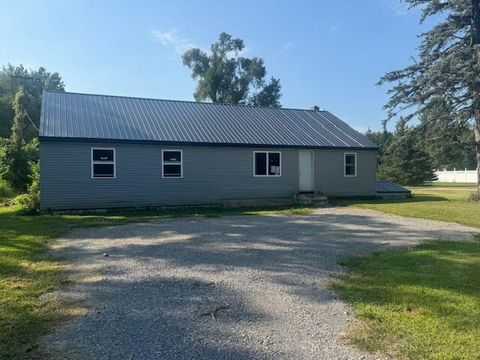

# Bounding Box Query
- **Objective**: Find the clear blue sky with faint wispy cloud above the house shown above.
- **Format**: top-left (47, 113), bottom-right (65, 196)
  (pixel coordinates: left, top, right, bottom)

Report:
top-left (0, 0), bottom-right (428, 131)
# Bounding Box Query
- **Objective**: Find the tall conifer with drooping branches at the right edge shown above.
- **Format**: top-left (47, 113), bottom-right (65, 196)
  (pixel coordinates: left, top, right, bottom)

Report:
top-left (379, 0), bottom-right (480, 194)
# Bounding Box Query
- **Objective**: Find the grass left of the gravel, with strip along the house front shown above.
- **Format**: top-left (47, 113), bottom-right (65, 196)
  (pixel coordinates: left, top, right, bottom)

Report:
top-left (0, 199), bottom-right (312, 359)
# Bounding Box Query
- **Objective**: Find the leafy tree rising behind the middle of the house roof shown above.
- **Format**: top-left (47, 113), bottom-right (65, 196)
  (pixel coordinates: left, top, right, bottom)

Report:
top-left (182, 33), bottom-right (281, 107)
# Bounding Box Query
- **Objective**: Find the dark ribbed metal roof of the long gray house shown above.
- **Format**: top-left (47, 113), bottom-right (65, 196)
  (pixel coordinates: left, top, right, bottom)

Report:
top-left (40, 91), bottom-right (376, 149)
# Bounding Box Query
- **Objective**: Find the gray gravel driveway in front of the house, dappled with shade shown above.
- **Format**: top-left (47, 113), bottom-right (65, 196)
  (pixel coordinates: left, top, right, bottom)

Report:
top-left (44, 208), bottom-right (475, 359)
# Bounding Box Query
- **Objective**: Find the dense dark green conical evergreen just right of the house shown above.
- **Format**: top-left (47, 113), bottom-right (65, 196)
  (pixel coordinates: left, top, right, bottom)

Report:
top-left (378, 121), bottom-right (436, 185)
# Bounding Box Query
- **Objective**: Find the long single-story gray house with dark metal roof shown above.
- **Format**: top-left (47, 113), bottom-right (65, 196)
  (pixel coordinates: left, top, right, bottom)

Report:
top-left (40, 92), bottom-right (377, 210)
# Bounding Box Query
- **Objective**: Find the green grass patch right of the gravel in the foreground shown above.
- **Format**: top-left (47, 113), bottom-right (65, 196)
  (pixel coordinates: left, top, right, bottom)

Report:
top-left (333, 239), bottom-right (480, 359)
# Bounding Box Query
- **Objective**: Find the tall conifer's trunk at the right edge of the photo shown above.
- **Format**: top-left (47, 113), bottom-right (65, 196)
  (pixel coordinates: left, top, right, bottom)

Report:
top-left (471, 0), bottom-right (480, 194)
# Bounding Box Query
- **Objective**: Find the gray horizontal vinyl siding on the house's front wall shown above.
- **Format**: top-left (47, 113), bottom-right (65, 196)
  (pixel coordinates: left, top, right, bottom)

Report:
top-left (40, 140), bottom-right (376, 209)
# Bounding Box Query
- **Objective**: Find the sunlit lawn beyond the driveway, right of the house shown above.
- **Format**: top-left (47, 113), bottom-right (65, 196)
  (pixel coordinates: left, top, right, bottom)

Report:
top-left (335, 186), bottom-right (480, 228)
